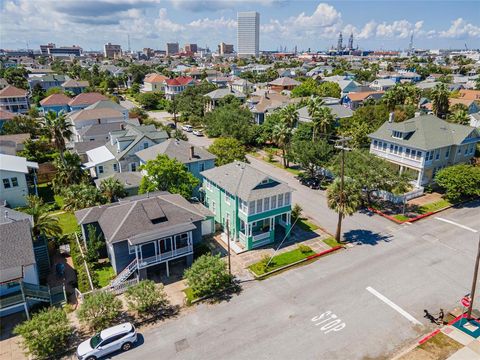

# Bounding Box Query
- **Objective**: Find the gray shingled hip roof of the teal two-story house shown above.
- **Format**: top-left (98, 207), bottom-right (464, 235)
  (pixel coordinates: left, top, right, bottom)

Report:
top-left (201, 161), bottom-right (292, 201)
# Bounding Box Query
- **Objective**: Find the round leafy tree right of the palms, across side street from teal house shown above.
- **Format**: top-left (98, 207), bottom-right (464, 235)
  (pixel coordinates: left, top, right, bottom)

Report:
top-left (292, 140), bottom-right (333, 177)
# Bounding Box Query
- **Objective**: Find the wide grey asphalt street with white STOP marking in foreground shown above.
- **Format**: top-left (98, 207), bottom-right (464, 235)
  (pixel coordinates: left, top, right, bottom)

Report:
top-left (115, 202), bottom-right (480, 359)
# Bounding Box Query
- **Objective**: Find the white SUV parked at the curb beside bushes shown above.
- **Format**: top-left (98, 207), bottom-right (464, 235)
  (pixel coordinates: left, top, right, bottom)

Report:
top-left (77, 323), bottom-right (137, 360)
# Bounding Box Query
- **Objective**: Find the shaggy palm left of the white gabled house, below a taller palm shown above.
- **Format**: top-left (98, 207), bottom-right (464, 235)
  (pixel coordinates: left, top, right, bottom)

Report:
top-left (52, 152), bottom-right (88, 194)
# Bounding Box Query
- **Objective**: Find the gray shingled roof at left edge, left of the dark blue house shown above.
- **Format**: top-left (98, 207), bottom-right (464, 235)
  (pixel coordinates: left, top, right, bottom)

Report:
top-left (0, 206), bottom-right (35, 283)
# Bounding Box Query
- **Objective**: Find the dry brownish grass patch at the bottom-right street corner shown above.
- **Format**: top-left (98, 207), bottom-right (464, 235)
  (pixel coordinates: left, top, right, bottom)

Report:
top-left (400, 332), bottom-right (463, 360)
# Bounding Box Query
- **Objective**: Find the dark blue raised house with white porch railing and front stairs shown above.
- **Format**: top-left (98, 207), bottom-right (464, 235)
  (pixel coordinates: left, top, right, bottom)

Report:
top-left (75, 192), bottom-right (213, 287)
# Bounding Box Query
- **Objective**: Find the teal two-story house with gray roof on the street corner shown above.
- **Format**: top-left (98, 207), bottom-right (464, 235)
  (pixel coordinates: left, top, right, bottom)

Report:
top-left (201, 161), bottom-right (292, 250)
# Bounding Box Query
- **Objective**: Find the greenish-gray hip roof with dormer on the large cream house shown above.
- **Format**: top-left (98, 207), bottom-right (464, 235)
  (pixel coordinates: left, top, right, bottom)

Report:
top-left (369, 115), bottom-right (480, 151)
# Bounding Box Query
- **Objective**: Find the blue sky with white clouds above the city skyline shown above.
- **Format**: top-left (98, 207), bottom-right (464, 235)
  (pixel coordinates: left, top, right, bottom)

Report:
top-left (0, 0), bottom-right (480, 51)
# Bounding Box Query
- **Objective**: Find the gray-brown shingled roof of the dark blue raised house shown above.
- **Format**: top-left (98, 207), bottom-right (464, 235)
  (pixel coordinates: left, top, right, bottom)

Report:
top-left (75, 193), bottom-right (205, 244)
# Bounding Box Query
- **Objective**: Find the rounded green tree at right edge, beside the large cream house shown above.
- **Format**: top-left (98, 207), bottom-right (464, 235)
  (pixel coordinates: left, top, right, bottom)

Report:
top-left (435, 164), bottom-right (480, 202)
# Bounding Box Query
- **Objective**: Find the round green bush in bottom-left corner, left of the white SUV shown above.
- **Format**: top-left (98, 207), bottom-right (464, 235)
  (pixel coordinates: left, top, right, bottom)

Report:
top-left (13, 307), bottom-right (74, 359)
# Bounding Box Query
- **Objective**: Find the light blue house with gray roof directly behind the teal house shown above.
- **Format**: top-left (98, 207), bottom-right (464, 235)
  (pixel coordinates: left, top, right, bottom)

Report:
top-left (135, 139), bottom-right (216, 195)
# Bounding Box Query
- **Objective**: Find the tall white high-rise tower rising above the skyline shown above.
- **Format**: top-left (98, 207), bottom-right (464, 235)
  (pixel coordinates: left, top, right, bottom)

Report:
top-left (237, 11), bottom-right (260, 57)
